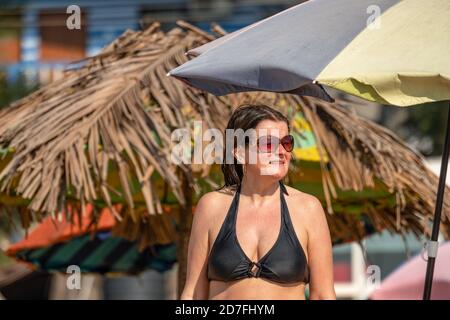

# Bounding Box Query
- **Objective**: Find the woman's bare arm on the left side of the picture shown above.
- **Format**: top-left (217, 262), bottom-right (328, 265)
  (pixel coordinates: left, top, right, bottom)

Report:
top-left (180, 194), bottom-right (210, 300)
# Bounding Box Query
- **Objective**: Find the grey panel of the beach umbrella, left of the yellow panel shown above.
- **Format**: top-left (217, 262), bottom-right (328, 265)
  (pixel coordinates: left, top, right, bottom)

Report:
top-left (169, 0), bottom-right (399, 101)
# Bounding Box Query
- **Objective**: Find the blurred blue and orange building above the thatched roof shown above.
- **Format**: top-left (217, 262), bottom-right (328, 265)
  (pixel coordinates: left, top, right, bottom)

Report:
top-left (0, 0), bottom-right (301, 82)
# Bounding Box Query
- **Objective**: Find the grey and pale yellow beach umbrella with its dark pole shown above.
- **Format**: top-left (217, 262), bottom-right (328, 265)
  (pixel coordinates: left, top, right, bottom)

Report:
top-left (168, 0), bottom-right (450, 299)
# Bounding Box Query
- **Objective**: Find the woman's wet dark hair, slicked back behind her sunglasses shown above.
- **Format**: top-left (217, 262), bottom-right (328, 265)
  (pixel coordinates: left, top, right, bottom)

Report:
top-left (222, 104), bottom-right (290, 188)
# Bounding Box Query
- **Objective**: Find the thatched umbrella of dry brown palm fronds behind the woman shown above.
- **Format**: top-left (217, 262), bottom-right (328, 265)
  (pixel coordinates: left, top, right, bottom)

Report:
top-left (0, 22), bottom-right (450, 294)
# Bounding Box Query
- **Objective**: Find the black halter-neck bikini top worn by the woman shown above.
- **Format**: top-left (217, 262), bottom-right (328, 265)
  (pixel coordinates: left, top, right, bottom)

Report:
top-left (208, 181), bottom-right (309, 283)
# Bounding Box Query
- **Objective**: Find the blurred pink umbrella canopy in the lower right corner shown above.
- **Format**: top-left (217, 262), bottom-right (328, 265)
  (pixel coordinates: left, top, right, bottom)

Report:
top-left (370, 242), bottom-right (450, 300)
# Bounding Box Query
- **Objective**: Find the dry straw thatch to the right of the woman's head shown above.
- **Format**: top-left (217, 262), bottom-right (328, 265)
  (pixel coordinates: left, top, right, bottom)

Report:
top-left (291, 97), bottom-right (450, 238)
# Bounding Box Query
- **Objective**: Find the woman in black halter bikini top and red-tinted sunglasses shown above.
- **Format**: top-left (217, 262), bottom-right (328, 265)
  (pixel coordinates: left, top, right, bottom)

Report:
top-left (181, 105), bottom-right (336, 299)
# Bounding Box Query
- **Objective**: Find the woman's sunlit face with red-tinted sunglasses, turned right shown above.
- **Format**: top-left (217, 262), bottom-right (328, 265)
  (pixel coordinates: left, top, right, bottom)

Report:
top-left (237, 120), bottom-right (293, 180)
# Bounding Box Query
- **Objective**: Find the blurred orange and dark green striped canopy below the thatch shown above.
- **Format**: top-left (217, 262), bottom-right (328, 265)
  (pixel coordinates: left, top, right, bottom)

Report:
top-left (6, 206), bottom-right (177, 274)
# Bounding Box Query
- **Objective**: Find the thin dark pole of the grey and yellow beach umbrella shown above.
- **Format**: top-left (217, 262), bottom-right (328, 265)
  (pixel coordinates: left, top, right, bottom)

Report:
top-left (423, 100), bottom-right (450, 300)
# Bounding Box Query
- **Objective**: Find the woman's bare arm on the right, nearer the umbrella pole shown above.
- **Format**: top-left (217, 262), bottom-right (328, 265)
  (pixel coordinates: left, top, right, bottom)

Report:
top-left (307, 197), bottom-right (336, 300)
